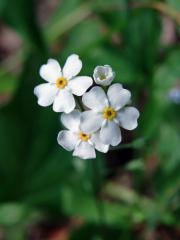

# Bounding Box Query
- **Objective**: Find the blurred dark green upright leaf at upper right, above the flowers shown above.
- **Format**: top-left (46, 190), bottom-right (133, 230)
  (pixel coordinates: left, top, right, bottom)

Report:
top-left (123, 9), bottom-right (160, 78)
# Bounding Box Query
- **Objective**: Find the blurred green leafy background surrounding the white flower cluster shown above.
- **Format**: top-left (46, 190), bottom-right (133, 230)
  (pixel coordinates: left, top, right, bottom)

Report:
top-left (0, 0), bottom-right (180, 240)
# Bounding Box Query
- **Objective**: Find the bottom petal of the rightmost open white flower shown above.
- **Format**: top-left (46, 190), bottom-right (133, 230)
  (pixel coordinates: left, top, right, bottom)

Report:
top-left (100, 121), bottom-right (121, 146)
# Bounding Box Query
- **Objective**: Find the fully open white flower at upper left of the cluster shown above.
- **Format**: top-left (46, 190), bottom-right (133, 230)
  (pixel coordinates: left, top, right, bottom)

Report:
top-left (34, 54), bottom-right (93, 113)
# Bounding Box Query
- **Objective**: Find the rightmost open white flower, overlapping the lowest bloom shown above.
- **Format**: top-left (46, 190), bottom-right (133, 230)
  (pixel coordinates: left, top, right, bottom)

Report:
top-left (81, 83), bottom-right (139, 146)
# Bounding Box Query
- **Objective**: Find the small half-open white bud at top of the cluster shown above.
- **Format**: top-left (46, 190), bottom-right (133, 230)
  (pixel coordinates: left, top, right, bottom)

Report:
top-left (93, 65), bottom-right (115, 86)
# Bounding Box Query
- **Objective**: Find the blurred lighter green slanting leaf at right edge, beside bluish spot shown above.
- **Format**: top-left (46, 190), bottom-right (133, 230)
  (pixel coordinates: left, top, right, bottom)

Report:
top-left (141, 49), bottom-right (180, 137)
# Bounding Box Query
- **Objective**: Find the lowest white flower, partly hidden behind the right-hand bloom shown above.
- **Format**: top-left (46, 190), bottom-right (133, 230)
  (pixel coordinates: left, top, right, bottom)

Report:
top-left (57, 110), bottom-right (109, 159)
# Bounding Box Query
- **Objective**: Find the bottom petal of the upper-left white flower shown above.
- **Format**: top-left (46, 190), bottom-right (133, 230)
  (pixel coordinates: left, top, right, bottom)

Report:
top-left (53, 89), bottom-right (75, 113)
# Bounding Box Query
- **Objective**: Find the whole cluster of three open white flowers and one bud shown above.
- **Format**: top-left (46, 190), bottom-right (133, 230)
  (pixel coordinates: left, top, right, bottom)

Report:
top-left (34, 54), bottom-right (139, 159)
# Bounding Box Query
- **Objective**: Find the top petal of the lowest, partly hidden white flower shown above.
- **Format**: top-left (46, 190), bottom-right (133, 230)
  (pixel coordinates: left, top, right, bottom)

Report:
top-left (61, 110), bottom-right (81, 132)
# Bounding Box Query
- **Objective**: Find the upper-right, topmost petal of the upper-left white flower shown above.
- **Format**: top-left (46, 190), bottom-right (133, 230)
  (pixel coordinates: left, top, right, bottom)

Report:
top-left (63, 54), bottom-right (82, 79)
